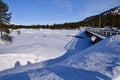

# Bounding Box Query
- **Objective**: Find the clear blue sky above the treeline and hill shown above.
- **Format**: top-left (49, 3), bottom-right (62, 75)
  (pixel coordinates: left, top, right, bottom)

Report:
top-left (4, 0), bottom-right (120, 25)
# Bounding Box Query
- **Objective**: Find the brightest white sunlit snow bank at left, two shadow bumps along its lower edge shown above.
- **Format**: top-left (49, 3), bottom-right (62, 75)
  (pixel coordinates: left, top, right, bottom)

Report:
top-left (0, 54), bottom-right (45, 71)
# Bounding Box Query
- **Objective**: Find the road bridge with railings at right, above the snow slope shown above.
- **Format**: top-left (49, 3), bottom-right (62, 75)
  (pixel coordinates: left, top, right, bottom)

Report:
top-left (86, 28), bottom-right (120, 43)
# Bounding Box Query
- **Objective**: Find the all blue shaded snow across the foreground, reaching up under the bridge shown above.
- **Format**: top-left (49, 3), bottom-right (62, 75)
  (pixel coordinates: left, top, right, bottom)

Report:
top-left (0, 28), bottom-right (120, 80)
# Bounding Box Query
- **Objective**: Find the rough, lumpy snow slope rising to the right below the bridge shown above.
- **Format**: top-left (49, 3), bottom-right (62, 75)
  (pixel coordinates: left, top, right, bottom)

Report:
top-left (60, 35), bottom-right (120, 80)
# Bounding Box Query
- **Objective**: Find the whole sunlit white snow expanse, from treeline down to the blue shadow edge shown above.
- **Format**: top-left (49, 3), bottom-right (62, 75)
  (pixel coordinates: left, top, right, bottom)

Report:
top-left (0, 29), bottom-right (79, 71)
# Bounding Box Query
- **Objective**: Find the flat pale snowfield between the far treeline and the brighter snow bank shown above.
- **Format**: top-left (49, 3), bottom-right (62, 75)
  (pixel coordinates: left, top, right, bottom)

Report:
top-left (0, 29), bottom-right (79, 59)
